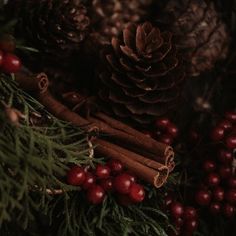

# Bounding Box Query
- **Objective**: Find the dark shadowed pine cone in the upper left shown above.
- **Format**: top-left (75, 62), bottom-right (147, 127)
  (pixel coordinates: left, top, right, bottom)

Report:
top-left (7, 0), bottom-right (90, 58)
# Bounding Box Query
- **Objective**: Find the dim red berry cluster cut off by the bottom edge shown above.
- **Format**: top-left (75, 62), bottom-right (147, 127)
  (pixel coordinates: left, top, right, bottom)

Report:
top-left (165, 195), bottom-right (198, 236)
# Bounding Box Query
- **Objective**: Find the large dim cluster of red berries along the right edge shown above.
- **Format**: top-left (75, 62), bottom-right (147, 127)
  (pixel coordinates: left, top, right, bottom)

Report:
top-left (196, 112), bottom-right (236, 218)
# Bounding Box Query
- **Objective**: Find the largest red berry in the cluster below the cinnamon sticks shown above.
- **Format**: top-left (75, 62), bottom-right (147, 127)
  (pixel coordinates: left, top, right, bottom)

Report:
top-left (113, 173), bottom-right (132, 194)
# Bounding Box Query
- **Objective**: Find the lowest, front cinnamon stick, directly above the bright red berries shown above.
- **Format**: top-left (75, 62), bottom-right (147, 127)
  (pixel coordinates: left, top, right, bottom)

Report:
top-left (95, 139), bottom-right (169, 188)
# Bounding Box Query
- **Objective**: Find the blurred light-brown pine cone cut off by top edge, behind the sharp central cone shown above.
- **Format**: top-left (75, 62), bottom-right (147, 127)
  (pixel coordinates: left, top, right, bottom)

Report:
top-left (87, 0), bottom-right (152, 44)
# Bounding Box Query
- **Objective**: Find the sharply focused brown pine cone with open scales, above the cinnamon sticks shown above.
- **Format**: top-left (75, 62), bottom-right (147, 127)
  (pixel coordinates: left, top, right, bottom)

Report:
top-left (98, 22), bottom-right (185, 125)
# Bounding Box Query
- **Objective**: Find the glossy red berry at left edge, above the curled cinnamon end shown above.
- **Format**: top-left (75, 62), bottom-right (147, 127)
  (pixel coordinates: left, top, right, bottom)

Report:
top-left (1, 53), bottom-right (21, 73)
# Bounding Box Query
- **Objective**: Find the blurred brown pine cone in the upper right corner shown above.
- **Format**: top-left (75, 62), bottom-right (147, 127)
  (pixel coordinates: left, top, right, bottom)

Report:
top-left (154, 0), bottom-right (229, 76)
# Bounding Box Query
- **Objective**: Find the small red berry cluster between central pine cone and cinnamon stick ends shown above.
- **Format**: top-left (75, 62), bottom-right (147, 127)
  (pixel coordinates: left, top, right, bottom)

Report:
top-left (144, 118), bottom-right (179, 145)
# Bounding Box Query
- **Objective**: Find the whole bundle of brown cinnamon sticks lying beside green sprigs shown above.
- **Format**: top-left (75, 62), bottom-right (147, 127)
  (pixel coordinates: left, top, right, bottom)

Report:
top-left (16, 72), bottom-right (175, 188)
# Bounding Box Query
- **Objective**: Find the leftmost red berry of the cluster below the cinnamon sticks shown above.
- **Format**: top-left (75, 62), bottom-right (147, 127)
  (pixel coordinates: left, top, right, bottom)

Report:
top-left (67, 166), bottom-right (85, 186)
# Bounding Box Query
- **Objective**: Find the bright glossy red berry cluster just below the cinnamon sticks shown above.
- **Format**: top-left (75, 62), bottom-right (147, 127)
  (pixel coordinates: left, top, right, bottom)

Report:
top-left (67, 160), bottom-right (145, 205)
